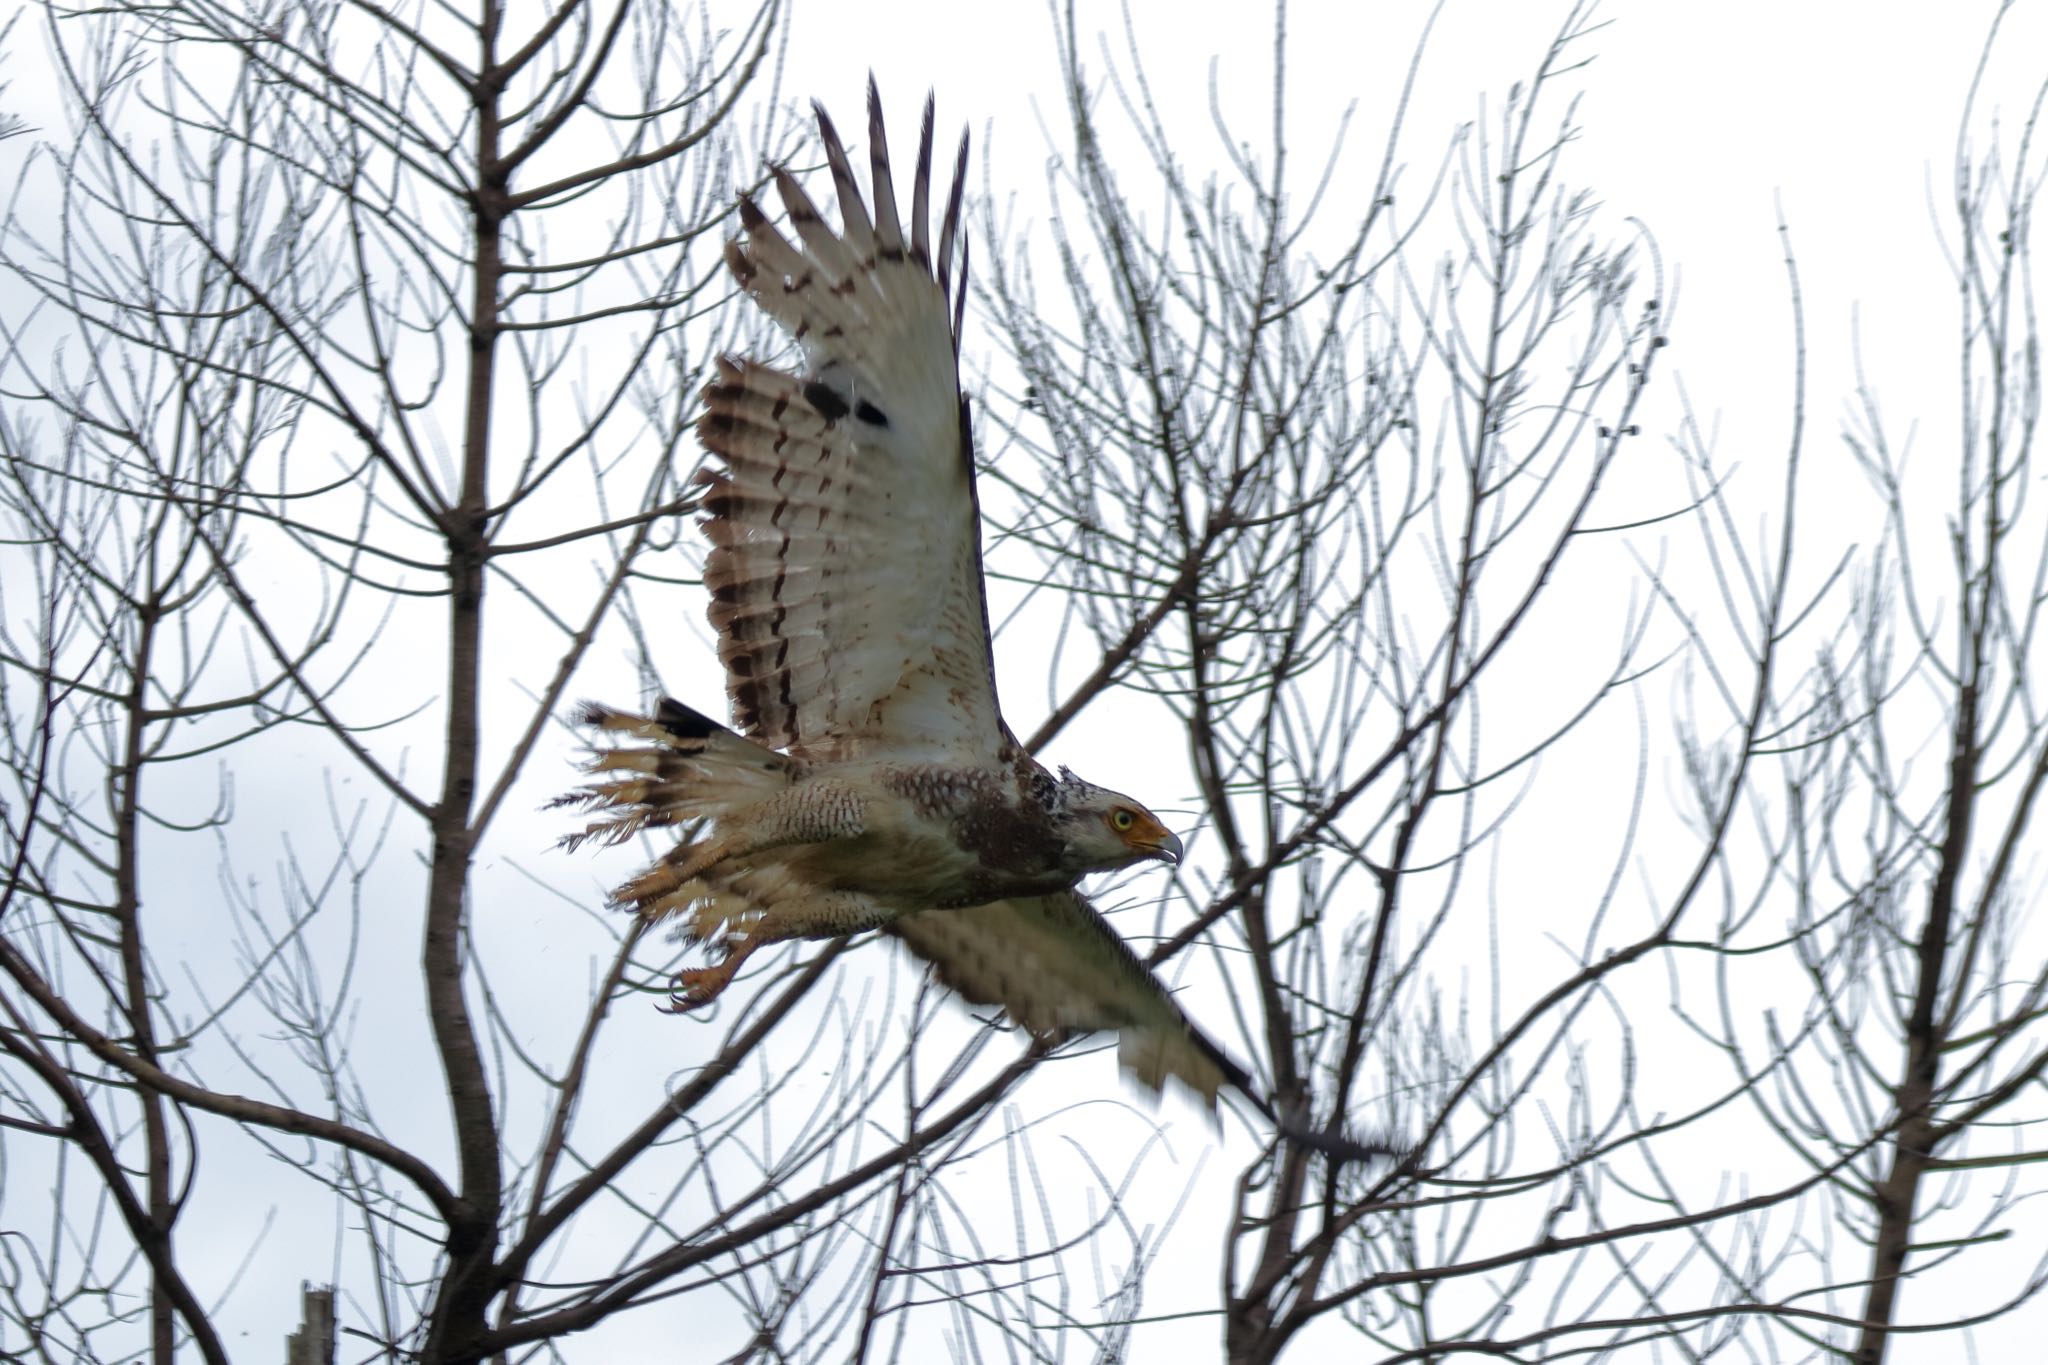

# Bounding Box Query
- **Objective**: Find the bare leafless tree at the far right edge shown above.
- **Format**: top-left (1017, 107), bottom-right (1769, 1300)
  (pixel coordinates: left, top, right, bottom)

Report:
top-left (1753, 6), bottom-right (2048, 1365)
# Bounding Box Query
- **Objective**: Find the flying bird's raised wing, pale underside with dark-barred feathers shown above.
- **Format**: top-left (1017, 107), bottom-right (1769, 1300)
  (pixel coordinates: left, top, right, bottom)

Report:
top-left (698, 82), bottom-right (1008, 763)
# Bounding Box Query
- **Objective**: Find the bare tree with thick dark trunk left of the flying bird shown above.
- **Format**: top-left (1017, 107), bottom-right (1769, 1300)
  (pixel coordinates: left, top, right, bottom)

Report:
top-left (0, 0), bottom-right (999, 1361)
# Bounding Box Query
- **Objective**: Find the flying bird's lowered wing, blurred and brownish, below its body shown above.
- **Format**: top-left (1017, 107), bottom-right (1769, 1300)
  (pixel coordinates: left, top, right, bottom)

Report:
top-left (889, 890), bottom-right (1260, 1107)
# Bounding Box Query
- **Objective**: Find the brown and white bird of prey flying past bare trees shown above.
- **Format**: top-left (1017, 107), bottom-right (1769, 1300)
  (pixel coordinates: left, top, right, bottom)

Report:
top-left (565, 84), bottom-right (1249, 1103)
